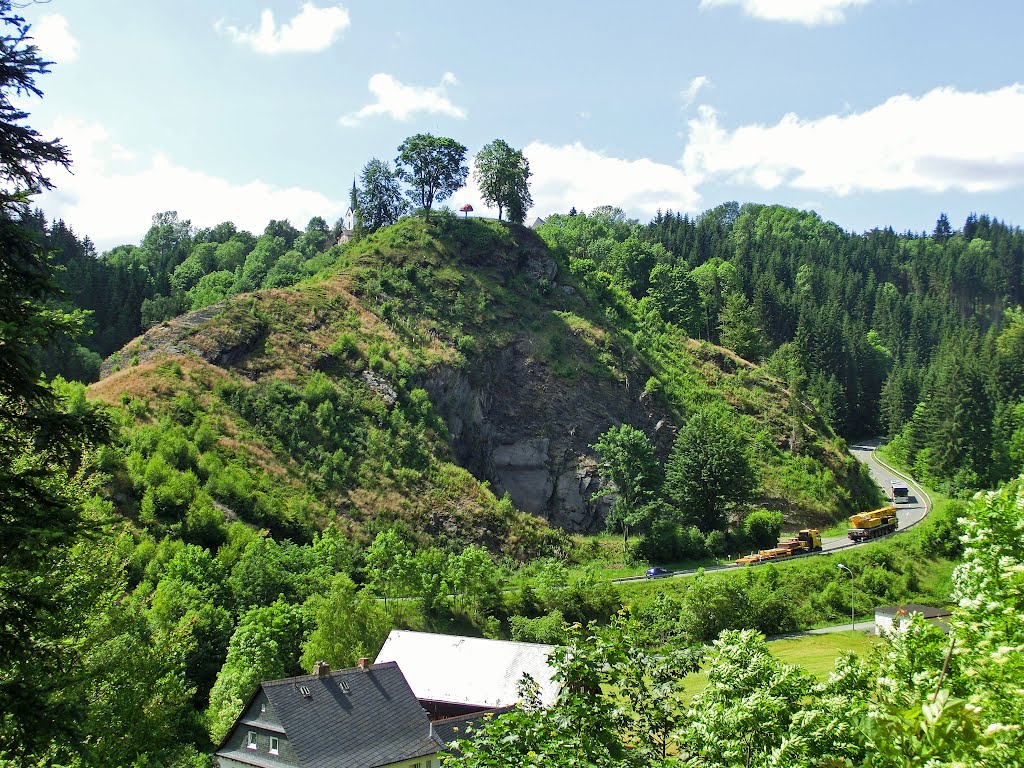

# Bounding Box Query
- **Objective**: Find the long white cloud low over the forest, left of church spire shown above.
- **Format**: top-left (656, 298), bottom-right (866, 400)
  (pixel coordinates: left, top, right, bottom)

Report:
top-left (38, 120), bottom-right (345, 249)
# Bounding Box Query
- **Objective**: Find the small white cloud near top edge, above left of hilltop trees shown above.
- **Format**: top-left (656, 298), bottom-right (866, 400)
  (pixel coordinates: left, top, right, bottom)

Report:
top-left (214, 3), bottom-right (351, 53)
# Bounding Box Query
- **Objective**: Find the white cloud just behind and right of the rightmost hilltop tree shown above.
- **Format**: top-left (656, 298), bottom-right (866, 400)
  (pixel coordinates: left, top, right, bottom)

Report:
top-left (451, 141), bottom-right (700, 217)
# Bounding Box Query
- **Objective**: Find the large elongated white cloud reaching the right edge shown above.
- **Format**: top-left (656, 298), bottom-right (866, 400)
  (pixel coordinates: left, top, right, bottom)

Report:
top-left (683, 84), bottom-right (1024, 195)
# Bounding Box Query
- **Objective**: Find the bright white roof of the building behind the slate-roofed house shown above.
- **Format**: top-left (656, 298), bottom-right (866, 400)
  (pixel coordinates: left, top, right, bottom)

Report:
top-left (377, 630), bottom-right (558, 707)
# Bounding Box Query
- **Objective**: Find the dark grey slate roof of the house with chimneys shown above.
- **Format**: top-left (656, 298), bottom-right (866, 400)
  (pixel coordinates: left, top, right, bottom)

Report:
top-left (217, 663), bottom-right (441, 768)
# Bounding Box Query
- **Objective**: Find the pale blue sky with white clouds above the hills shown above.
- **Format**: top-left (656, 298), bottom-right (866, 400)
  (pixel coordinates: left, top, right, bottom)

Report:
top-left (19, 0), bottom-right (1024, 250)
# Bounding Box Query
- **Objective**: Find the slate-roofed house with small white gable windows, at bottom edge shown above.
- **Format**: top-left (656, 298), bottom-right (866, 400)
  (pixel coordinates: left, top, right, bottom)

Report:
top-left (215, 659), bottom-right (444, 768)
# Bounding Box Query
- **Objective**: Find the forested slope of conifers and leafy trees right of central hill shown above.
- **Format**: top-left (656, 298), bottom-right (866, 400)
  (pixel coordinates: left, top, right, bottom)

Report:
top-left (541, 203), bottom-right (1024, 493)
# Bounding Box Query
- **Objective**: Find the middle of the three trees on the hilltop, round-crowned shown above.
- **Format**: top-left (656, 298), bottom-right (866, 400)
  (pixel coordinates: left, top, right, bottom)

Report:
top-left (394, 133), bottom-right (469, 221)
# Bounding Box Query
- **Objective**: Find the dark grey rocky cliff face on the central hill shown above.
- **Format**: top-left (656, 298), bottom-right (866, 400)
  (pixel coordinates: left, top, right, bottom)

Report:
top-left (422, 338), bottom-right (675, 532)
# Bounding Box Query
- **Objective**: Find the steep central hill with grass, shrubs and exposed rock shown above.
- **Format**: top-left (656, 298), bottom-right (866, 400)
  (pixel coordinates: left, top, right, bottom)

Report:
top-left (90, 216), bottom-right (869, 557)
